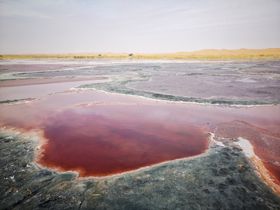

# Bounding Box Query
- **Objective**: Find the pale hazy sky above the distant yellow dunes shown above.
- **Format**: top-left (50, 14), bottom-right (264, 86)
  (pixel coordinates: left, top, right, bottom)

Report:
top-left (0, 0), bottom-right (280, 54)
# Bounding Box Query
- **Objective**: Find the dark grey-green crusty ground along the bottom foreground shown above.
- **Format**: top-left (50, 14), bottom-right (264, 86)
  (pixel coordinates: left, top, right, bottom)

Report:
top-left (0, 131), bottom-right (280, 210)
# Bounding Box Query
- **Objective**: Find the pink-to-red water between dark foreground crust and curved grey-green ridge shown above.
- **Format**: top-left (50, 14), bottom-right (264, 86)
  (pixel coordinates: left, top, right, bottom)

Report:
top-left (0, 85), bottom-right (280, 180)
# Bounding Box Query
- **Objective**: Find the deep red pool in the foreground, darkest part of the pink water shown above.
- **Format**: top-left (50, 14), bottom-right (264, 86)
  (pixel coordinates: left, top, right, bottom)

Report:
top-left (40, 106), bottom-right (207, 176)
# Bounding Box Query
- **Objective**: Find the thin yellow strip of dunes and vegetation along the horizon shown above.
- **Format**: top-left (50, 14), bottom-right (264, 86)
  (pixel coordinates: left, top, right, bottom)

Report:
top-left (0, 48), bottom-right (280, 60)
